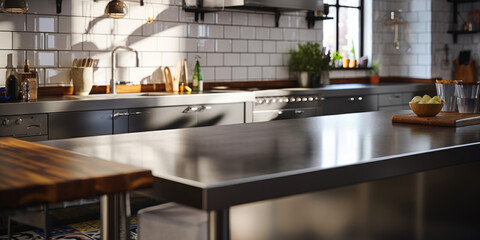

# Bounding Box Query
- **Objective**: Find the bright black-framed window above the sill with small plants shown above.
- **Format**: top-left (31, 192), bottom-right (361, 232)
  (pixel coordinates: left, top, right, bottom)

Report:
top-left (323, 0), bottom-right (364, 59)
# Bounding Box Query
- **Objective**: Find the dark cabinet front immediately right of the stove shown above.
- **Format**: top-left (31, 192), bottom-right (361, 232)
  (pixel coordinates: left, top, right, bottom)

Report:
top-left (322, 95), bottom-right (378, 115)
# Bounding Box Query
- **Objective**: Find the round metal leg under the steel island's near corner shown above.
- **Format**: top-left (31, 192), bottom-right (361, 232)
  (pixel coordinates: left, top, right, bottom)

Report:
top-left (208, 208), bottom-right (230, 240)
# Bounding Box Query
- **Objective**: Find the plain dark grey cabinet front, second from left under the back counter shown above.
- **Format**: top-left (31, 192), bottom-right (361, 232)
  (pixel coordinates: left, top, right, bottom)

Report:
top-left (48, 110), bottom-right (113, 139)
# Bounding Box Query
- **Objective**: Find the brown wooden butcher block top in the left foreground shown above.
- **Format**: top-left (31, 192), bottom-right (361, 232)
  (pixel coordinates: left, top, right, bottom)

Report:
top-left (0, 138), bottom-right (153, 209)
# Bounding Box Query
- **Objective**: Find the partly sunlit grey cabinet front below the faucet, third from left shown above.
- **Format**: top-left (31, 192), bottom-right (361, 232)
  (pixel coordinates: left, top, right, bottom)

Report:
top-left (128, 106), bottom-right (198, 132)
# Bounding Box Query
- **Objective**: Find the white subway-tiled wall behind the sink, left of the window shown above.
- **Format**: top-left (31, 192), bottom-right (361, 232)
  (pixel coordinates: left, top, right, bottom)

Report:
top-left (0, 0), bottom-right (323, 86)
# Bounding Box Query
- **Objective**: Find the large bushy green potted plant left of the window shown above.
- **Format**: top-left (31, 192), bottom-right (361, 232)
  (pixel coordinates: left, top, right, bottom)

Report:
top-left (288, 43), bottom-right (331, 87)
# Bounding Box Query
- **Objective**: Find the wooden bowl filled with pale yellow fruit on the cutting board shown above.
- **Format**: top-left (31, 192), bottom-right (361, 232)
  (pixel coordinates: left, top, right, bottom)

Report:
top-left (409, 95), bottom-right (444, 117)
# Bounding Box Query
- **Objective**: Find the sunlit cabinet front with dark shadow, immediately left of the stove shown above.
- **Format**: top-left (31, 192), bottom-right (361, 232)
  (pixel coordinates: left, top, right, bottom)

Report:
top-left (198, 103), bottom-right (245, 126)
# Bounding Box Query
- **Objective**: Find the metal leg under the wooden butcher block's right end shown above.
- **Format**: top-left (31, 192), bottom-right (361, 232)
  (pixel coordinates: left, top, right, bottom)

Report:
top-left (100, 193), bottom-right (130, 240)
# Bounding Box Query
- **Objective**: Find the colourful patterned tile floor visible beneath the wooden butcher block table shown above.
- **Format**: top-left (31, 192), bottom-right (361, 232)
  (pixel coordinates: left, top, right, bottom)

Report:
top-left (0, 217), bottom-right (137, 240)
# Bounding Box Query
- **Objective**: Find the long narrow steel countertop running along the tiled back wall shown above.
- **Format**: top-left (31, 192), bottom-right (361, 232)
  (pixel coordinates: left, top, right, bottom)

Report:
top-left (0, 83), bottom-right (435, 115)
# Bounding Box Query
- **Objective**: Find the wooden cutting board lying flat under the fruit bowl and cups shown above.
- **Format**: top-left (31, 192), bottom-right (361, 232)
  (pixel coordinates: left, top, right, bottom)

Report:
top-left (392, 112), bottom-right (480, 127)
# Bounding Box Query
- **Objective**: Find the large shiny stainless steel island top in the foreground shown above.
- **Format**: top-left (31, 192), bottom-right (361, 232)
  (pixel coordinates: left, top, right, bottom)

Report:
top-left (41, 111), bottom-right (480, 210)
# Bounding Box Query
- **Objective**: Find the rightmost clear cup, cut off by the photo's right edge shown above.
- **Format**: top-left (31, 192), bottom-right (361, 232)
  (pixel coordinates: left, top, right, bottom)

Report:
top-left (455, 83), bottom-right (480, 113)
